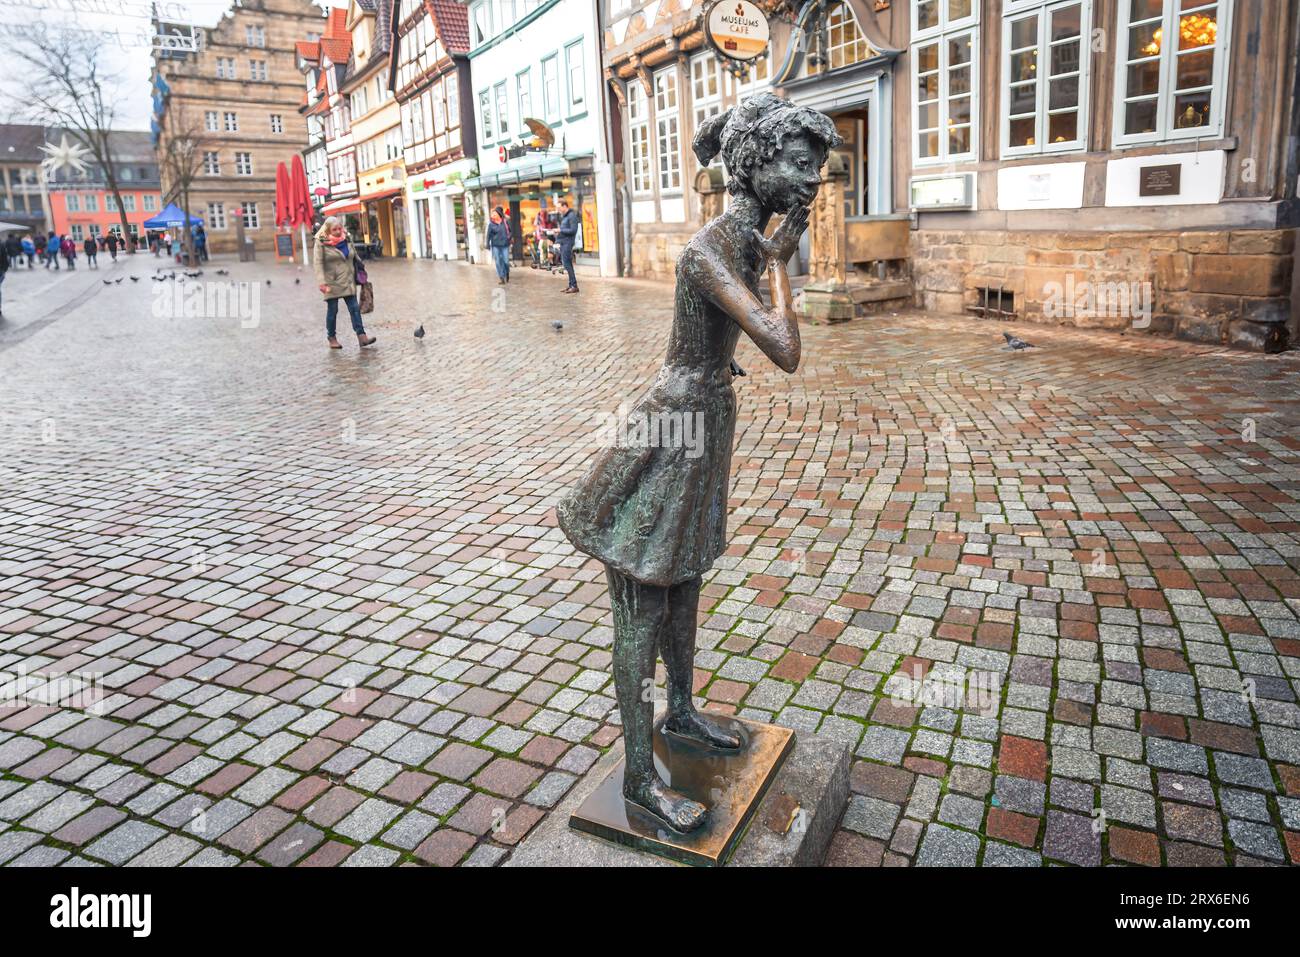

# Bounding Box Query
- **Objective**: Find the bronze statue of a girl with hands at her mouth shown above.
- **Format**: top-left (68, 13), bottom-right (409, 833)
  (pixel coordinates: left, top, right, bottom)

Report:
top-left (558, 94), bottom-right (840, 831)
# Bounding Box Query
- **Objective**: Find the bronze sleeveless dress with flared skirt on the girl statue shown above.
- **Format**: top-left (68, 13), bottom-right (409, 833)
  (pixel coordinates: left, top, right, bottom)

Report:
top-left (556, 216), bottom-right (758, 585)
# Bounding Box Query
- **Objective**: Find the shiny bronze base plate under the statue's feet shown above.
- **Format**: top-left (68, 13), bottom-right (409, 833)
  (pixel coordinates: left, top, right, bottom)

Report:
top-left (569, 715), bottom-right (794, 867)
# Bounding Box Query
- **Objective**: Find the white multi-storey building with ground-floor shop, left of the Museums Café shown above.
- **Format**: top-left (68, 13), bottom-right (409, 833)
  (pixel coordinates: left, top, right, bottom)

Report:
top-left (465, 0), bottom-right (618, 276)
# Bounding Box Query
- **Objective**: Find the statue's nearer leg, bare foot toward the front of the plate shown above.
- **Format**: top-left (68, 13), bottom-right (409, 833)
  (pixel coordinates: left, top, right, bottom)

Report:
top-left (605, 566), bottom-right (707, 831)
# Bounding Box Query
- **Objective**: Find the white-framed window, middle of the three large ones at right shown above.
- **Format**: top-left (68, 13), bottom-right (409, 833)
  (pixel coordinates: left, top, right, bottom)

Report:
top-left (1001, 0), bottom-right (1092, 156)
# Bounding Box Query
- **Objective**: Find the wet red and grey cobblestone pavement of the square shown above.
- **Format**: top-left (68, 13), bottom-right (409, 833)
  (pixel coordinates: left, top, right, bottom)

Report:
top-left (0, 257), bottom-right (1300, 865)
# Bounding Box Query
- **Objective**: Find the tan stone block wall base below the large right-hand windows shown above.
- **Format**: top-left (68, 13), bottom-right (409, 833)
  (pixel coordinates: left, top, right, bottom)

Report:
top-left (911, 229), bottom-right (1295, 352)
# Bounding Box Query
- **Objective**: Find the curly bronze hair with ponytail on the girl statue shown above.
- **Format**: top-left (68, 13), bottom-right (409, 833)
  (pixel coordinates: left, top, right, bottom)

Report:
top-left (692, 94), bottom-right (842, 192)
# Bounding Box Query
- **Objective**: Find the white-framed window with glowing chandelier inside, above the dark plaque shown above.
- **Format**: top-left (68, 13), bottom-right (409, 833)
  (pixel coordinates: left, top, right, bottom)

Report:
top-left (1113, 0), bottom-right (1232, 146)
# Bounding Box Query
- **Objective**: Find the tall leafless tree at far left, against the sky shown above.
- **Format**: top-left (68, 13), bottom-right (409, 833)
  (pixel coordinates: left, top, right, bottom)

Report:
top-left (0, 22), bottom-right (135, 252)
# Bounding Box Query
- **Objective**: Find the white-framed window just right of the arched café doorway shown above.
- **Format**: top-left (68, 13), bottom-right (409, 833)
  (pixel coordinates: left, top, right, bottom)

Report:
top-left (911, 21), bottom-right (979, 165)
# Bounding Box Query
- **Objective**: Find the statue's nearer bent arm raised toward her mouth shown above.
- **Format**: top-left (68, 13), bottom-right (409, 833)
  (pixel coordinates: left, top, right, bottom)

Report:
top-left (684, 250), bottom-right (801, 372)
